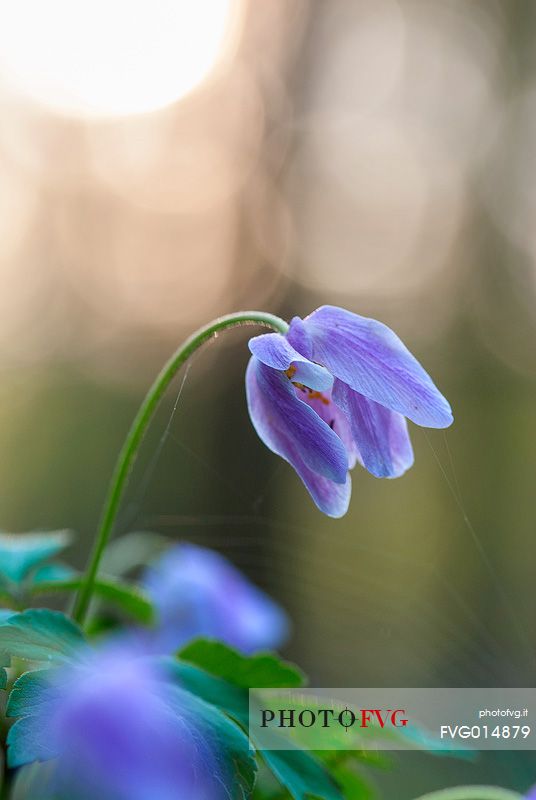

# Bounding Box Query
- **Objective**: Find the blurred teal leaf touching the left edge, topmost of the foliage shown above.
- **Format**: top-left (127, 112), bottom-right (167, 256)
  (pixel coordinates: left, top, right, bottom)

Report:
top-left (0, 531), bottom-right (71, 583)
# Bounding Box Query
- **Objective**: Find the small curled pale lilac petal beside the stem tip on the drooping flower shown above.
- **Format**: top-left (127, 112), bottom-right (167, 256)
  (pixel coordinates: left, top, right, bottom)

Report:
top-left (249, 333), bottom-right (333, 392)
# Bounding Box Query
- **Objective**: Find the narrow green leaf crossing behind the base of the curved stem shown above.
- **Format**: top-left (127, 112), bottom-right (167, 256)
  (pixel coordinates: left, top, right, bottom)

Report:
top-left (31, 576), bottom-right (155, 625)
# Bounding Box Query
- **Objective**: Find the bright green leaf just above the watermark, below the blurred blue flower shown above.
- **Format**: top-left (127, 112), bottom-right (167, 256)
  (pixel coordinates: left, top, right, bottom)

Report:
top-left (179, 639), bottom-right (305, 689)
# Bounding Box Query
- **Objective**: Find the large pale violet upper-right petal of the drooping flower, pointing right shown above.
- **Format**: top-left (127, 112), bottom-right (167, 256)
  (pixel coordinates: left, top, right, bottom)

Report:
top-left (304, 306), bottom-right (452, 428)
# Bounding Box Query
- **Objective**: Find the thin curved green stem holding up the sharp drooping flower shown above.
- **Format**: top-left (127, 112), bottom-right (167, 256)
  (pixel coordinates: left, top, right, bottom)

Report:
top-left (73, 311), bottom-right (288, 625)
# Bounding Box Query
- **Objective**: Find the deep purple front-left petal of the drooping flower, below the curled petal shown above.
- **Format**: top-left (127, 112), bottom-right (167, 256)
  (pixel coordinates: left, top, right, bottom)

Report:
top-left (246, 357), bottom-right (348, 484)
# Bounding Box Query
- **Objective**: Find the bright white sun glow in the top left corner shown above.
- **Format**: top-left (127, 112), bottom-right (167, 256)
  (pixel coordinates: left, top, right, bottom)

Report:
top-left (0, 0), bottom-right (237, 116)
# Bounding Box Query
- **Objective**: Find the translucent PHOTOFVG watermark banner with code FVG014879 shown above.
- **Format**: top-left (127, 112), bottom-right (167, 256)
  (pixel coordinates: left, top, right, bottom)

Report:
top-left (249, 688), bottom-right (536, 751)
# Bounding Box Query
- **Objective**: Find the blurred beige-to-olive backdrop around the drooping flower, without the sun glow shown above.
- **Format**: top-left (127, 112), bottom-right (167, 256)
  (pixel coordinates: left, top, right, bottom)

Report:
top-left (0, 0), bottom-right (536, 800)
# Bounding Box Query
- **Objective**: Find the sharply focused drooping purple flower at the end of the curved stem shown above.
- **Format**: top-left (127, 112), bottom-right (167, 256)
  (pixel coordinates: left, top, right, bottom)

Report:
top-left (246, 306), bottom-right (452, 517)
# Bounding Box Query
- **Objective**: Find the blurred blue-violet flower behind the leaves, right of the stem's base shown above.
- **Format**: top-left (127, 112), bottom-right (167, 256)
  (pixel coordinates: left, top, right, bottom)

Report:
top-left (142, 544), bottom-right (288, 653)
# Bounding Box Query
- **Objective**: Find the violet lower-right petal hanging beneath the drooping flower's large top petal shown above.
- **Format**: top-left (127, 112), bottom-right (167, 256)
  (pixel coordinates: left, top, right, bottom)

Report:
top-left (333, 380), bottom-right (413, 478)
